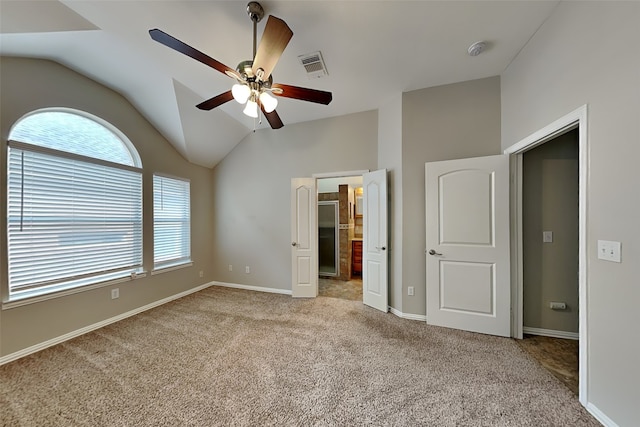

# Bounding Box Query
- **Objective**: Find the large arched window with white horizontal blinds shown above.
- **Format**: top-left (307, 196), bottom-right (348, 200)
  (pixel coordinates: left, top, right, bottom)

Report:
top-left (7, 109), bottom-right (142, 300)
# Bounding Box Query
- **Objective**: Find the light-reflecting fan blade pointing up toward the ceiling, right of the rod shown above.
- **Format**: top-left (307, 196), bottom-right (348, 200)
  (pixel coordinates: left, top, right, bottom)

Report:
top-left (252, 16), bottom-right (293, 81)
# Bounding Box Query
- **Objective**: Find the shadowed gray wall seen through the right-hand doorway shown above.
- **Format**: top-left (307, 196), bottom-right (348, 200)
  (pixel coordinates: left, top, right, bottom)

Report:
top-left (522, 130), bottom-right (578, 332)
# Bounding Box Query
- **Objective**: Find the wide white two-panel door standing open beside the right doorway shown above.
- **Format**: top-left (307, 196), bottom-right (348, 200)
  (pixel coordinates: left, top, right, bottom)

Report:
top-left (425, 155), bottom-right (511, 337)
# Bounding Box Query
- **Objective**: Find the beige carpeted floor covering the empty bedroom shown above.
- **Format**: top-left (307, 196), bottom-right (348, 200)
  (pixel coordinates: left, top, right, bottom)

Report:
top-left (0, 287), bottom-right (599, 427)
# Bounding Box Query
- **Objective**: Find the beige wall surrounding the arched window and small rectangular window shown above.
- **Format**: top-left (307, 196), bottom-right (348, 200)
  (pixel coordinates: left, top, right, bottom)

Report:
top-left (0, 57), bottom-right (213, 356)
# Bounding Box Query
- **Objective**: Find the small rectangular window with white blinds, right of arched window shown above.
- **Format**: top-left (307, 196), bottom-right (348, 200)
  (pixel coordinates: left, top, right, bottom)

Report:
top-left (153, 175), bottom-right (191, 269)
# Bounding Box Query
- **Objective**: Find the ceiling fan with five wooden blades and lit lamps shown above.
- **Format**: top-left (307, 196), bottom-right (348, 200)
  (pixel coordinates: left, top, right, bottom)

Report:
top-left (149, 1), bottom-right (333, 129)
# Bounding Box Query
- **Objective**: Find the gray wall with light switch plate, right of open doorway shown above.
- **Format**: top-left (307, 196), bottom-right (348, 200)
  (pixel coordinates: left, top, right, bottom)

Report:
top-left (502, 2), bottom-right (640, 426)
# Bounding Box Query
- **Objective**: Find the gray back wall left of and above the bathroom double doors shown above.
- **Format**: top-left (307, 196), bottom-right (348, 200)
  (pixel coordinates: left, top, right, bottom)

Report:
top-left (211, 111), bottom-right (378, 290)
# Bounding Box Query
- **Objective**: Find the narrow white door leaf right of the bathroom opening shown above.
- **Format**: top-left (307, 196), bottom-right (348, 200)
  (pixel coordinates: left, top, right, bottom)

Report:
top-left (362, 169), bottom-right (389, 313)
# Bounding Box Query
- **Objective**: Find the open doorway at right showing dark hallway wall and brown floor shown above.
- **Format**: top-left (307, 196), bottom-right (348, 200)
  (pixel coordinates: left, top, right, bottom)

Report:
top-left (518, 128), bottom-right (579, 395)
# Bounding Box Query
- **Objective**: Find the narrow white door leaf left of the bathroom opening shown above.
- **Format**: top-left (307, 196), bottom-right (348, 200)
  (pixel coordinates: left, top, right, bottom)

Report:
top-left (291, 178), bottom-right (318, 298)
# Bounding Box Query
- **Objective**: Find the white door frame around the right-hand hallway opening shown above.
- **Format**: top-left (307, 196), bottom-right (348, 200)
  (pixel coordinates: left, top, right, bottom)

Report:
top-left (504, 104), bottom-right (589, 406)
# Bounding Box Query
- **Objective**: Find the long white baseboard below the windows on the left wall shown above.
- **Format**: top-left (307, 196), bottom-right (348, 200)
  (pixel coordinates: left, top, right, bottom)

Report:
top-left (0, 283), bottom-right (212, 365)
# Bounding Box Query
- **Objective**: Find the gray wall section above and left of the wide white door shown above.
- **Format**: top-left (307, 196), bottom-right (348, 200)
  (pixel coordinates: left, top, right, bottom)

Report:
top-left (402, 77), bottom-right (500, 315)
